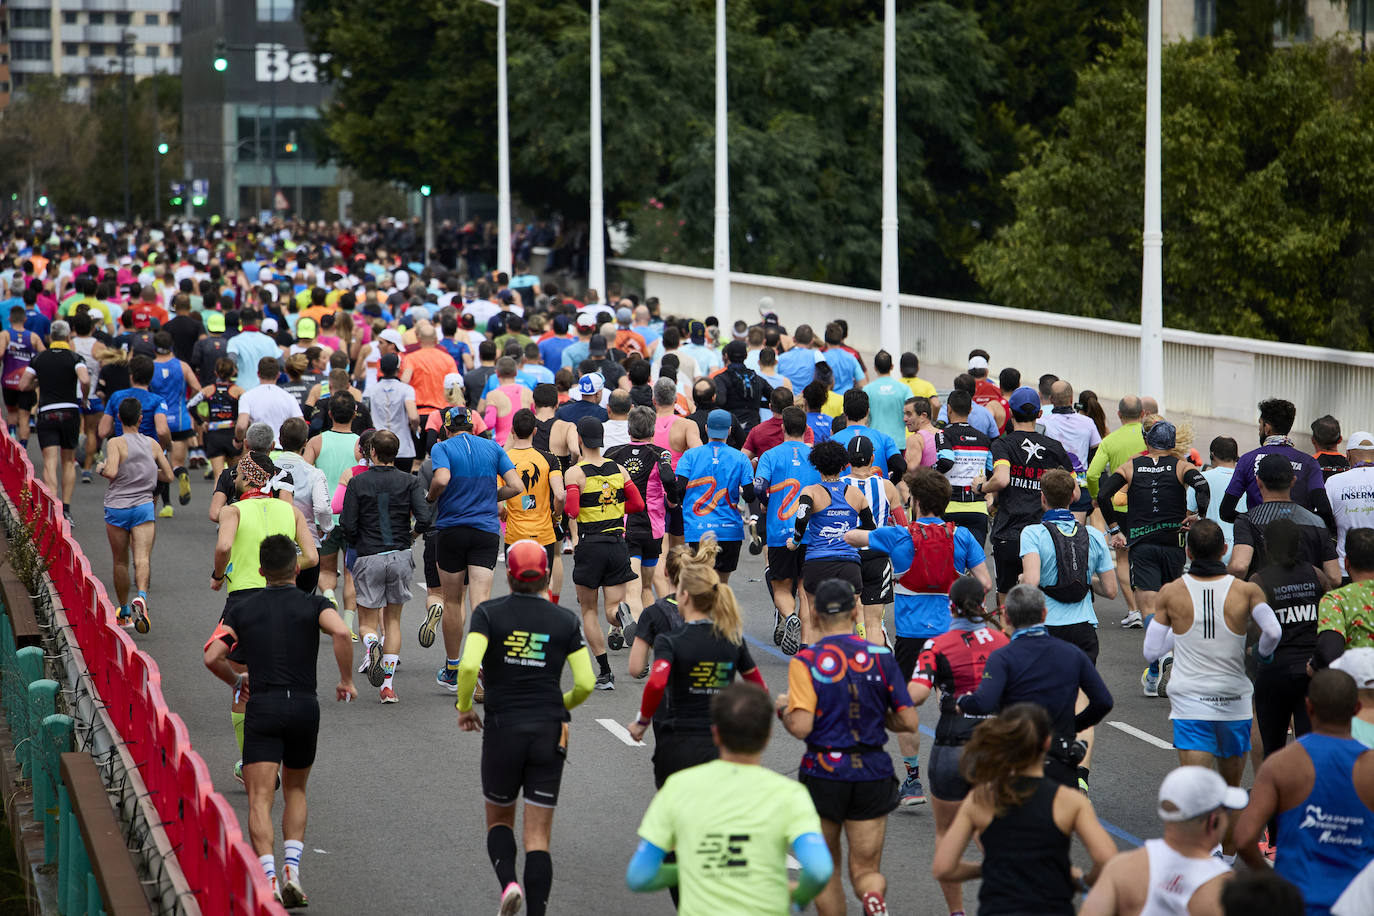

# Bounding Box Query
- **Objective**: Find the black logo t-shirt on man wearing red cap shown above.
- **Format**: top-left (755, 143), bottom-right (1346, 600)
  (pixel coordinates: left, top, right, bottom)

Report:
top-left (469, 596), bottom-right (583, 728)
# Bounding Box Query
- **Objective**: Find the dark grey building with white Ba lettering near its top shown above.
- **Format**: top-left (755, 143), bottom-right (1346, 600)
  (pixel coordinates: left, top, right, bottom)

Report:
top-left (181, 0), bottom-right (338, 220)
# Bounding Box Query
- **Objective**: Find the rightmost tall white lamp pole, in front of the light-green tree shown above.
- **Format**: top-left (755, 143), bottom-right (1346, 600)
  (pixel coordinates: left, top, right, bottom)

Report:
top-left (1140, 0), bottom-right (1164, 411)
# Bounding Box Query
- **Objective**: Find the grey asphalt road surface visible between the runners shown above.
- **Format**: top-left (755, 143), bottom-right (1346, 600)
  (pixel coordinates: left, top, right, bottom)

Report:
top-left (56, 448), bottom-right (1203, 916)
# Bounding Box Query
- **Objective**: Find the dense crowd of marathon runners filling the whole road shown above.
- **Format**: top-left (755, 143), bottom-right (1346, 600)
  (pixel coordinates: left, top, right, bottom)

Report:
top-left (0, 221), bottom-right (1374, 916)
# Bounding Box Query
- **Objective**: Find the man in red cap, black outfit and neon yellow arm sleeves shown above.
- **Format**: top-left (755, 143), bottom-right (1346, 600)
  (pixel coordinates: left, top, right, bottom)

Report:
top-left (458, 541), bottom-right (592, 916)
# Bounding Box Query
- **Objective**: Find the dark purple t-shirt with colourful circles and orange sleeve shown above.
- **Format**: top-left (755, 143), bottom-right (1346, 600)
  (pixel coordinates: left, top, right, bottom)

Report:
top-left (787, 634), bottom-right (911, 783)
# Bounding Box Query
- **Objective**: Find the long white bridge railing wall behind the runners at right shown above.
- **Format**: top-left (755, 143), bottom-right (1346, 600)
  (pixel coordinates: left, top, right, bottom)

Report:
top-left (609, 258), bottom-right (1374, 434)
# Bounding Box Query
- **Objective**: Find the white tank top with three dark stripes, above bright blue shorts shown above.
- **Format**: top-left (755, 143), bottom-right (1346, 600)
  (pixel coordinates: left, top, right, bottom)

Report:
top-left (1169, 575), bottom-right (1254, 722)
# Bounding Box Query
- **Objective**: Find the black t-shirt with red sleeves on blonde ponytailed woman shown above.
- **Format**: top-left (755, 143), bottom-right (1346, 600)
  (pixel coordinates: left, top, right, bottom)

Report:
top-left (654, 621), bottom-right (757, 735)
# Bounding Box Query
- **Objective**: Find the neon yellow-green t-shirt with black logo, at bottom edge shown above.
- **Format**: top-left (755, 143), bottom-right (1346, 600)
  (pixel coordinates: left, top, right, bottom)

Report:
top-left (639, 761), bottom-right (820, 916)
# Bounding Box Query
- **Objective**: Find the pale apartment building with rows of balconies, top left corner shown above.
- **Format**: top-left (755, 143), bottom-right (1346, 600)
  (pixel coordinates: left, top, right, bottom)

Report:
top-left (0, 0), bottom-right (181, 106)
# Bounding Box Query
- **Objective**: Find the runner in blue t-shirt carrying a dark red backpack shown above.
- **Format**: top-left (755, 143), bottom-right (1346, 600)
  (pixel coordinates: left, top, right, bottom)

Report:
top-left (845, 467), bottom-right (992, 806)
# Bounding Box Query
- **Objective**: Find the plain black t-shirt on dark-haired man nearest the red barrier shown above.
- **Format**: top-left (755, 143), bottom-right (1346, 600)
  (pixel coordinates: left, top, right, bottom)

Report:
top-left (224, 585), bottom-right (334, 694)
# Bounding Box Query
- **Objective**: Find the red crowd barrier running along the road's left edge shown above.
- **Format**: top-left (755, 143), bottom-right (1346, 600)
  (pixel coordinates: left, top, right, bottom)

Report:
top-left (0, 433), bottom-right (286, 916)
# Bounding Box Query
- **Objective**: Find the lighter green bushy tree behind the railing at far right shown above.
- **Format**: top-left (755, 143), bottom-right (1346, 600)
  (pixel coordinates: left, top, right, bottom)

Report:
top-left (970, 26), bottom-right (1374, 349)
